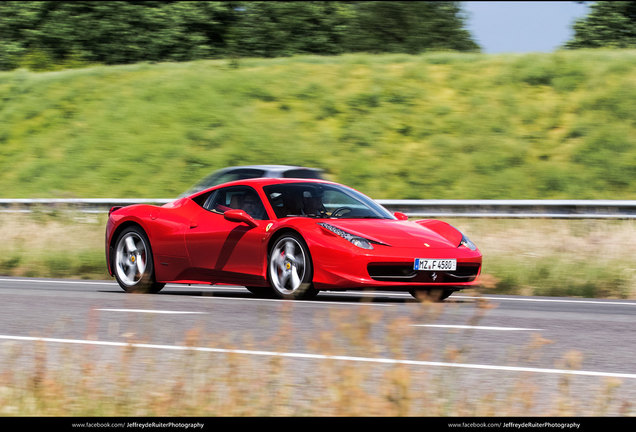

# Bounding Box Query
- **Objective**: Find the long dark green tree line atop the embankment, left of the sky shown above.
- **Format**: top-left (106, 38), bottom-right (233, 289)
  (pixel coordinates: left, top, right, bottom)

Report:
top-left (0, 1), bottom-right (479, 70)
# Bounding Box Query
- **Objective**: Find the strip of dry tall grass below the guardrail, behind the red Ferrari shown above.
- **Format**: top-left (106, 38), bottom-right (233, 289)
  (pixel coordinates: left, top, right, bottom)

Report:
top-left (0, 212), bottom-right (636, 298)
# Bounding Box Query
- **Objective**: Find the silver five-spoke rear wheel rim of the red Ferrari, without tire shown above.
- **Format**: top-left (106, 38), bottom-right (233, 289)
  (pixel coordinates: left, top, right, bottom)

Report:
top-left (115, 232), bottom-right (148, 287)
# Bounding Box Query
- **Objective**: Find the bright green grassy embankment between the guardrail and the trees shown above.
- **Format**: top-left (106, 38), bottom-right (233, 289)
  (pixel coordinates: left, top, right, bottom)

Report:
top-left (0, 50), bottom-right (636, 199)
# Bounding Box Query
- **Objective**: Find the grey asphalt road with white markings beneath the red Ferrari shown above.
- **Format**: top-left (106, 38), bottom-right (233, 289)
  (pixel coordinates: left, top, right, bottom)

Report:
top-left (0, 278), bottom-right (636, 415)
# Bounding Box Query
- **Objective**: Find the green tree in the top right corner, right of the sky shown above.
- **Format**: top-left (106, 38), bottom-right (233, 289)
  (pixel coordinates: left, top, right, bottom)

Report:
top-left (565, 1), bottom-right (636, 48)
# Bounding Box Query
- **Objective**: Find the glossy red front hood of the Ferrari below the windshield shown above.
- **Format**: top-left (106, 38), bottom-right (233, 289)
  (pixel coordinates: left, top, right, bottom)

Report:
top-left (324, 219), bottom-right (462, 249)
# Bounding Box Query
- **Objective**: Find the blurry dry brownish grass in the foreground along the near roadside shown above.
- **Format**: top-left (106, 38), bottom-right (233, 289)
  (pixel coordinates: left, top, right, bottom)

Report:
top-left (0, 301), bottom-right (634, 417)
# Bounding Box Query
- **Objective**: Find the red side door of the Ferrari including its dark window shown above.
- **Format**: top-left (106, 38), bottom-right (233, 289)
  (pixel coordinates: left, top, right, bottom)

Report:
top-left (185, 186), bottom-right (267, 285)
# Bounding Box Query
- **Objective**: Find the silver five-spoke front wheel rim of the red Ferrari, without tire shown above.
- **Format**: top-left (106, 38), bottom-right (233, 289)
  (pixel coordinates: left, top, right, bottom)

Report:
top-left (269, 237), bottom-right (307, 296)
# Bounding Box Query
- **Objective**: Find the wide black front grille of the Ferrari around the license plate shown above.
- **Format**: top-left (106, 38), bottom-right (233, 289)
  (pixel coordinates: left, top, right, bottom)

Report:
top-left (367, 263), bottom-right (479, 283)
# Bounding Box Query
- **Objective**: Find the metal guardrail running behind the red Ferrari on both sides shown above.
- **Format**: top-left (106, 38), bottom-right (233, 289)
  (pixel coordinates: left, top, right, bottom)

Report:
top-left (0, 198), bottom-right (636, 219)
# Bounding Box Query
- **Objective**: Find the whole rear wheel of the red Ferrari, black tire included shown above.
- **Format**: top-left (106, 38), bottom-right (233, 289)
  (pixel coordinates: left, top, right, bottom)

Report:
top-left (111, 226), bottom-right (165, 293)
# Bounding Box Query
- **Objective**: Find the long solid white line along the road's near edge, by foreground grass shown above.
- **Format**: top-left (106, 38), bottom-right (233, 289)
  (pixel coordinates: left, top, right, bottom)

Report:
top-left (0, 335), bottom-right (636, 379)
